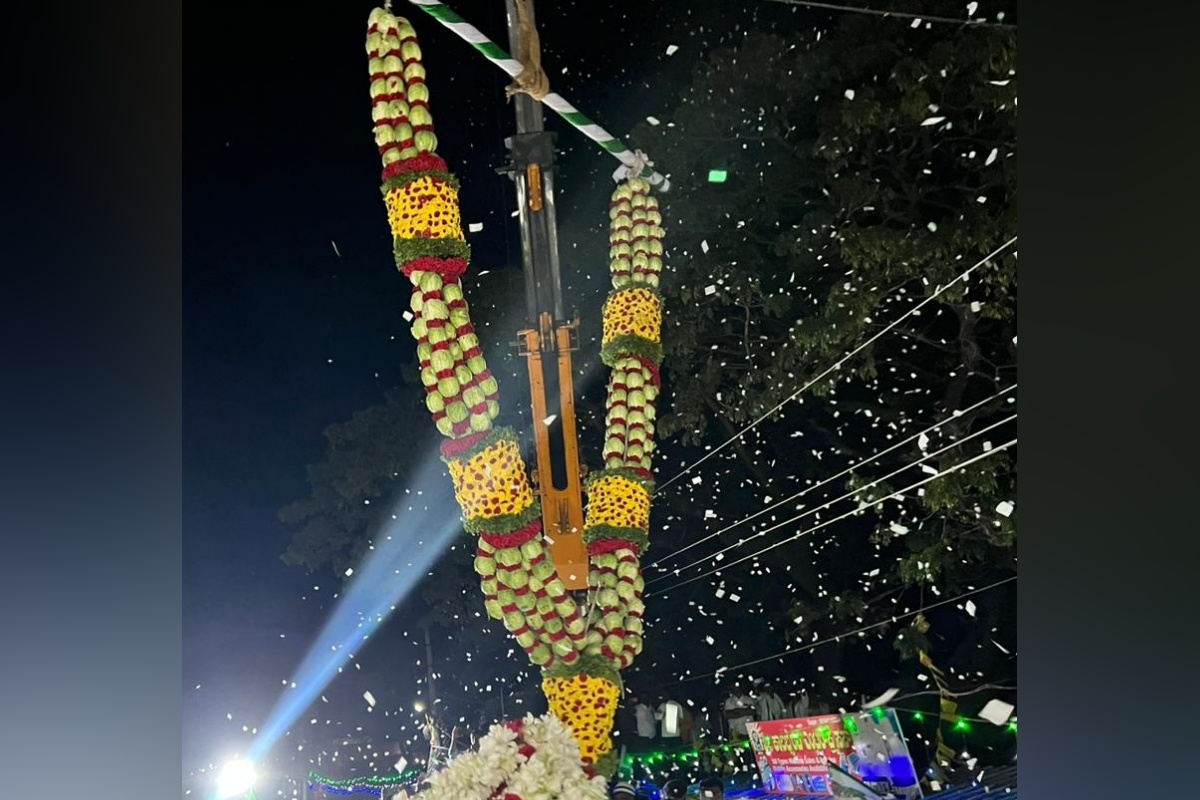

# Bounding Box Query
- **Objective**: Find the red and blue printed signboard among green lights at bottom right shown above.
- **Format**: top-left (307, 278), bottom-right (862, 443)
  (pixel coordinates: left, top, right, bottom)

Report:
top-left (746, 708), bottom-right (922, 798)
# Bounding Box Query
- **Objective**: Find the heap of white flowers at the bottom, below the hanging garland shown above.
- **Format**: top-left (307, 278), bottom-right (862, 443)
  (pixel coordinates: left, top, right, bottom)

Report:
top-left (416, 714), bottom-right (607, 800)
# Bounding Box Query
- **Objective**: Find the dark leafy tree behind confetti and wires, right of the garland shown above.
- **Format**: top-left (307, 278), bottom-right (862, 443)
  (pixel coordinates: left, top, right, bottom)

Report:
top-left (634, 4), bottom-right (1016, 686)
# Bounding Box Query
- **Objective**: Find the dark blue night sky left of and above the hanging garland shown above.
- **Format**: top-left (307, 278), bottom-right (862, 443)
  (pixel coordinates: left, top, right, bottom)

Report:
top-left (182, 0), bottom-right (818, 775)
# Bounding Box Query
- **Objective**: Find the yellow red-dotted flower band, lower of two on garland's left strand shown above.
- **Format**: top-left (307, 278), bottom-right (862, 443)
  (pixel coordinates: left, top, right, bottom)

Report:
top-left (446, 439), bottom-right (533, 519)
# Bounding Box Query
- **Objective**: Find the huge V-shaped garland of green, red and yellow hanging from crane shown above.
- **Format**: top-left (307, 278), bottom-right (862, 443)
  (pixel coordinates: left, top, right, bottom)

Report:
top-left (366, 8), bottom-right (662, 782)
